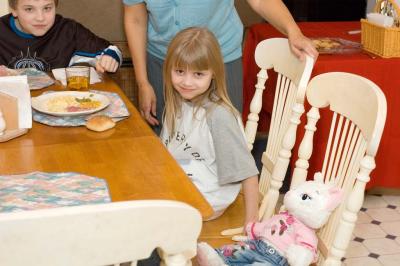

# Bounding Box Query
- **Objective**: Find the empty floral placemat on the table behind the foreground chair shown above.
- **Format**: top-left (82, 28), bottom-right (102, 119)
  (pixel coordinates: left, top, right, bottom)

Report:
top-left (0, 172), bottom-right (111, 212)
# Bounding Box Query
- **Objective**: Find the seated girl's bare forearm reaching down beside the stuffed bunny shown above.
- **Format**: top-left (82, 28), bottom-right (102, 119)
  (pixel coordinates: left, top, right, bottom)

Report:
top-left (242, 176), bottom-right (259, 228)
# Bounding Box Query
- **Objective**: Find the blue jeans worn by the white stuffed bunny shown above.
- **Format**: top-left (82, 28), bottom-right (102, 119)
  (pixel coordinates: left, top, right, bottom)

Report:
top-left (216, 240), bottom-right (289, 266)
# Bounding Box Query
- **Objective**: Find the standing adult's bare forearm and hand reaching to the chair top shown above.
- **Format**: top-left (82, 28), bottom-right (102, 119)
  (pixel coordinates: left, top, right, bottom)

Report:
top-left (247, 0), bottom-right (318, 60)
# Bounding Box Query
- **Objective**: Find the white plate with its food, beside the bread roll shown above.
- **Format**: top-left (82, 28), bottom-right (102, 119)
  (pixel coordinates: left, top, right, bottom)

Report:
top-left (32, 91), bottom-right (110, 116)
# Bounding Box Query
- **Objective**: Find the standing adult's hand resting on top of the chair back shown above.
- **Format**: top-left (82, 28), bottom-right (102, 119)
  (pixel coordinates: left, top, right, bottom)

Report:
top-left (288, 32), bottom-right (318, 61)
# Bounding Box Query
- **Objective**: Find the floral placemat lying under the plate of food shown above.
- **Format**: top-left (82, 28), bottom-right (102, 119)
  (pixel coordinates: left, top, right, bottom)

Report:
top-left (32, 90), bottom-right (129, 127)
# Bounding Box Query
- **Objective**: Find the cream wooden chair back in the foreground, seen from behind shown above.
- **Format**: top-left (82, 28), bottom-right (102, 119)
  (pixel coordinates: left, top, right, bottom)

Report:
top-left (0, 200), bottom-right (202, 266)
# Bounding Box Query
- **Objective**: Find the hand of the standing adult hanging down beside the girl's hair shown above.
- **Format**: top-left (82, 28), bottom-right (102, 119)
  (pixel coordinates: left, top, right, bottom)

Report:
top-left (139, 83), bottom-right (159, 126)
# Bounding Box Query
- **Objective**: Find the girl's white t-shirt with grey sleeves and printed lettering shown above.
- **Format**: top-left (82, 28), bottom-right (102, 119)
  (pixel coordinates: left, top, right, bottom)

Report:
top-left (161, 102), bottom-right (258, 218)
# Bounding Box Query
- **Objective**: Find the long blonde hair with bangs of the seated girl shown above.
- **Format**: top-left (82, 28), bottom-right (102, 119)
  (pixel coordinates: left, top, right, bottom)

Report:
top-left (163, 27), bottom-right (238, 136)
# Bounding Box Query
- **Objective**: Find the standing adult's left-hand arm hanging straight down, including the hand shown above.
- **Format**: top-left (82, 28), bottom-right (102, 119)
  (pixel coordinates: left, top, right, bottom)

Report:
top-left (124, 3), bottom-right (158, 125)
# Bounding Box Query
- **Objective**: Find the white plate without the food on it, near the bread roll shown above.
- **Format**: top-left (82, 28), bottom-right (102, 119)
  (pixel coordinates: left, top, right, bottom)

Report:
top-left (32, 91), bottom-right (110, 116)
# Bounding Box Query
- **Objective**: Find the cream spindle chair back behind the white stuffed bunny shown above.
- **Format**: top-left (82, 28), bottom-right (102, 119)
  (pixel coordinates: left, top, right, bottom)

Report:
top-left (291, 72), bottom-right (386, 265)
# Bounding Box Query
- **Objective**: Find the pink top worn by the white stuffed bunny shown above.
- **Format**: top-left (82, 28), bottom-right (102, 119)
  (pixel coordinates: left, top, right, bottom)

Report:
top-left (246, 212), bottom-right (318, 260)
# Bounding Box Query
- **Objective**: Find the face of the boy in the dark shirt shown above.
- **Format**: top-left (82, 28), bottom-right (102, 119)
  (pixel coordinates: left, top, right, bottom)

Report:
top-left (12, 0), bottom-right (56, 36)
